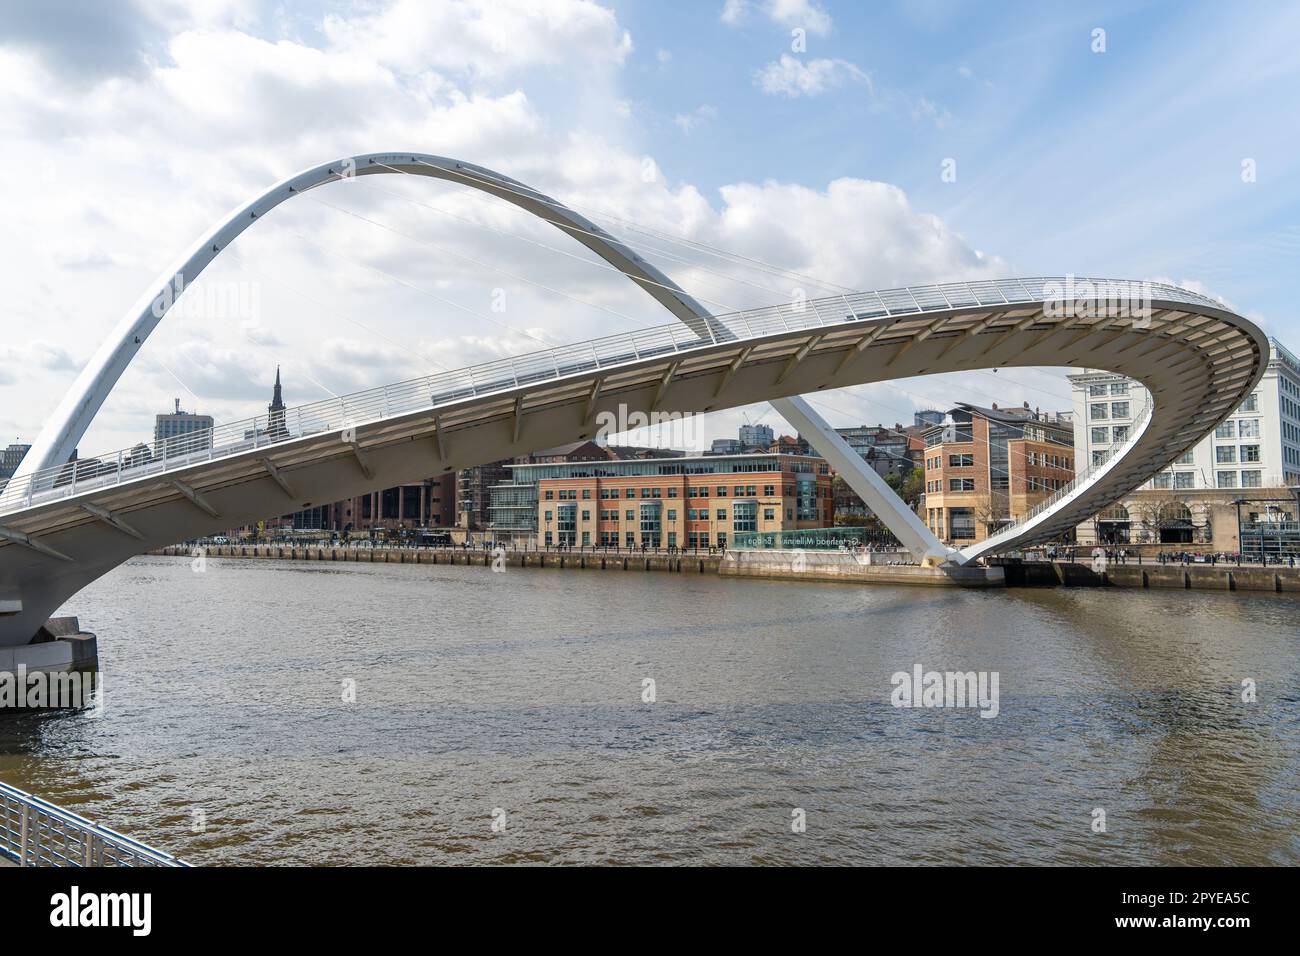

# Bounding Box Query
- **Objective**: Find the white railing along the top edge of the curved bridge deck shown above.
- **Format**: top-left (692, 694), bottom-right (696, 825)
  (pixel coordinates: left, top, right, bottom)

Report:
top-left (0, 277), bottom-right (1221, 515)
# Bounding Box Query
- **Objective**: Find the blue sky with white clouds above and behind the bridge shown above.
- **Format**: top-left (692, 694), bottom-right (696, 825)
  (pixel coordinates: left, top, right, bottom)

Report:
top-left (0, 0), bottom-right (1300, 454)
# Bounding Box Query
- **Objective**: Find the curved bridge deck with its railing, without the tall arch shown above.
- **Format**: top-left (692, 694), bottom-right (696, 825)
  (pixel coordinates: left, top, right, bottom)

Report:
top-left (0, 278), bottom-right (1269, 643)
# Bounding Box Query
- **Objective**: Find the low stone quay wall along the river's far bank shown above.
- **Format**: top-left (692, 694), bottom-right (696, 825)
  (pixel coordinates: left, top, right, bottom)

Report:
top-left (153, 544), bottom-right (1300, 593)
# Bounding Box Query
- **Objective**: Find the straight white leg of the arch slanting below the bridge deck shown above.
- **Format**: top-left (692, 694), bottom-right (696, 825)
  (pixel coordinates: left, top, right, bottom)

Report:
top-left (771, 395), bottom-right (966, 566)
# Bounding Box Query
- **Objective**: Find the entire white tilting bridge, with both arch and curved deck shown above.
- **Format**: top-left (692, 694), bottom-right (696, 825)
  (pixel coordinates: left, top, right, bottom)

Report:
top-left (0, 153), bottom-right (1269, 666)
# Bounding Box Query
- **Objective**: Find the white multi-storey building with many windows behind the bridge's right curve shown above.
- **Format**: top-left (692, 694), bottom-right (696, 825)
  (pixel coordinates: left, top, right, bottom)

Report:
top-left (1069, 338), bottom-right (1300, 544)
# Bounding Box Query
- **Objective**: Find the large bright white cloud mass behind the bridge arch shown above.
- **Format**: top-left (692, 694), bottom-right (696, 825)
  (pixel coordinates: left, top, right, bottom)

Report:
top-left (0, 0), bottom-right (1001, 453)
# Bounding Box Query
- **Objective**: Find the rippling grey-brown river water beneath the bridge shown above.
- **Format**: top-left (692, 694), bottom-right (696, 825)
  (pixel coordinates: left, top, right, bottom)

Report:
top-left (0, 558), bottom-right (1300, 865)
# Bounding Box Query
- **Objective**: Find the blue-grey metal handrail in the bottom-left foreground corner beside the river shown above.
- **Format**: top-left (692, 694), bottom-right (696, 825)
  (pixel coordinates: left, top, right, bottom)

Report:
top-left (0, 783), bottom-right (189, 866)
